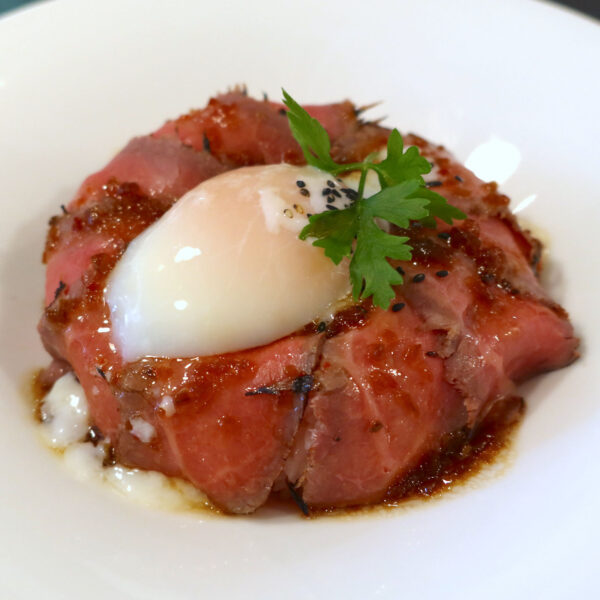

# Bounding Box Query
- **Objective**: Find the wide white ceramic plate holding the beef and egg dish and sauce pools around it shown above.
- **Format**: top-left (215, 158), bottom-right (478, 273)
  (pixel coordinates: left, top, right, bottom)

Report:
top-left (0, 0), bottom-right (600, 600)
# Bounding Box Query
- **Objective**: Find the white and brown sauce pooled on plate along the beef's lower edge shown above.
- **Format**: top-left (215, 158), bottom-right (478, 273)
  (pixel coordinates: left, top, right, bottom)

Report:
top-left (29, 370), bottom-right (524, 518)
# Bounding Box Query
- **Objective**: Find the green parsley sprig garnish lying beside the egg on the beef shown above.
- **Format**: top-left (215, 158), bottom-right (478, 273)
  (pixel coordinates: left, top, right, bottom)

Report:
top-left (282, 90), bottom-right (466, 308)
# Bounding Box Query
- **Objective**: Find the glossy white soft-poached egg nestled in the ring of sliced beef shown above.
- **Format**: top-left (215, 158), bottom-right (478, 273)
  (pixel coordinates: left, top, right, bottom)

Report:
top-left (105, 164), bottom-right (350, 361)
